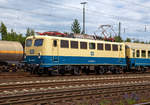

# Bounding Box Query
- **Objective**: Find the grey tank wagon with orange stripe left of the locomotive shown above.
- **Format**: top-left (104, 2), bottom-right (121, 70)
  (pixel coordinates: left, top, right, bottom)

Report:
top-left (0, 41), bottom-right (23, 71)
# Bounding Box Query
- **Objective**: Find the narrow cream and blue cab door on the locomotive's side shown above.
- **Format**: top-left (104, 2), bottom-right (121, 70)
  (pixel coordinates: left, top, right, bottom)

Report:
top-left (52, 39), bottom-right (59, 64)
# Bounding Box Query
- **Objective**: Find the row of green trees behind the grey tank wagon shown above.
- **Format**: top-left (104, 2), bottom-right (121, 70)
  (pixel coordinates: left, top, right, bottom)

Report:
top-left (0, 22), bottom-right (35, 46)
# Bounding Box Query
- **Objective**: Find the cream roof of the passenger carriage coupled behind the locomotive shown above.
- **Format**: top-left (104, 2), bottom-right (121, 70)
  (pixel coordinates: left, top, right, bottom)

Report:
top-left (125, 42), bottom-right (150, 50)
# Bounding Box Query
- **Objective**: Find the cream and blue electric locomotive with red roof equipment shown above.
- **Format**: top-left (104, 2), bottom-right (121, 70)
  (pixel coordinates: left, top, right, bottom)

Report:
top-left (25, 35), bottom-right (127, 75)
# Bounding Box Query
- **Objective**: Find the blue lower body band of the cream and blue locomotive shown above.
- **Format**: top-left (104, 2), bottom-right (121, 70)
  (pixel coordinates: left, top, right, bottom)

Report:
top-left (25, 56), bottom-right (126, 67)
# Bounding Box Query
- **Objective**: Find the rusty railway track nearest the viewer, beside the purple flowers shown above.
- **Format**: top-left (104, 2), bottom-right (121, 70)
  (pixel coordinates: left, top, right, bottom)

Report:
top-left (0, 81), bottom-right (150, 105)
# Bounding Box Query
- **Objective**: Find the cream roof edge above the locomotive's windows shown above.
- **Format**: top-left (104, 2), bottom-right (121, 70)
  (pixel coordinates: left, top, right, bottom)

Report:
top-left (27, 35), bottom-right (124, 44)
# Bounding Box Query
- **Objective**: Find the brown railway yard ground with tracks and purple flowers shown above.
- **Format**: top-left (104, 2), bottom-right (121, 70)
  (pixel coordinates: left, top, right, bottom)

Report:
top-left (0, 71), bottom-right (150, 105)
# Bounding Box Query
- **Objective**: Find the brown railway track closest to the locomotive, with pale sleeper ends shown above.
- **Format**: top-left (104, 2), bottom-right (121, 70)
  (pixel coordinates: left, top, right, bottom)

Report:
top-left (0, 76), bottom-right (150, 93)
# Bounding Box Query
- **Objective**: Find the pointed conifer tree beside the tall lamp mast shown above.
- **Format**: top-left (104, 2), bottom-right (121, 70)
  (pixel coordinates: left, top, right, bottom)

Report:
top-left (71, 19), bottom-right (81, 34)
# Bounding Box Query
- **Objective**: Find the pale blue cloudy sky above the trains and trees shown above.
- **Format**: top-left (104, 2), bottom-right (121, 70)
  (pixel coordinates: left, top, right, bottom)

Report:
top-left (0, 0), bottom-right (150, 41)
